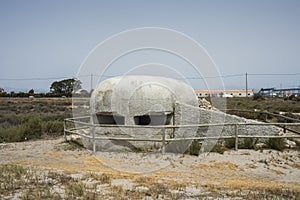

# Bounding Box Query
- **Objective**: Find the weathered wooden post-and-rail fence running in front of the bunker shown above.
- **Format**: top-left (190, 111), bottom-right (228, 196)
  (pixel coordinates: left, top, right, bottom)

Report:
top-left (64, 116), bottom-right (300, 154)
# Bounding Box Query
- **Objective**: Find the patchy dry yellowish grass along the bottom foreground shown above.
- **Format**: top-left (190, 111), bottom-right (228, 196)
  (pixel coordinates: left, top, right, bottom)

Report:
top-left (2, 156), bottom-right (300, 199)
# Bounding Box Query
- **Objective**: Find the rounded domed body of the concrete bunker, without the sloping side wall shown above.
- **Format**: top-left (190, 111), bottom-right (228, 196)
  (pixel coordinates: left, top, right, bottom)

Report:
top-left (89, 75), bottom-right (199, 152)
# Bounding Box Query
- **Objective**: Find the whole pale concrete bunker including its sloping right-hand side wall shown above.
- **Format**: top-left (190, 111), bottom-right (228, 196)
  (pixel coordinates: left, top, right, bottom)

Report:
top-left (84, 76), bottom-right (279, 153)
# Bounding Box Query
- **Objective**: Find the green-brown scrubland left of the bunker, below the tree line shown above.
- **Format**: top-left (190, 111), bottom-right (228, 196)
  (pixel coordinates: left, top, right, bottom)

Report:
top-left (0, 98), bottom-right (72, 143)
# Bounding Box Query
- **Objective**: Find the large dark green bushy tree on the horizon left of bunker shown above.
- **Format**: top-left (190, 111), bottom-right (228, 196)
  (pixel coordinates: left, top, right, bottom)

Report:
top-left (50, 78), bottom-right (81, 97)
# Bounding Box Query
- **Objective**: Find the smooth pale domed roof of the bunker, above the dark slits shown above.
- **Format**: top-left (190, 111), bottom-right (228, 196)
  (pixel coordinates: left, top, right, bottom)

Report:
top-left (91, 75), bottom-right (198, 120)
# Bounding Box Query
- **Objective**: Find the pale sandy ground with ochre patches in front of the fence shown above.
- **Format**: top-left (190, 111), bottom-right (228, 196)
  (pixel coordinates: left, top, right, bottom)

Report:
top-left (0, 138), bottom-right (300, 198)
